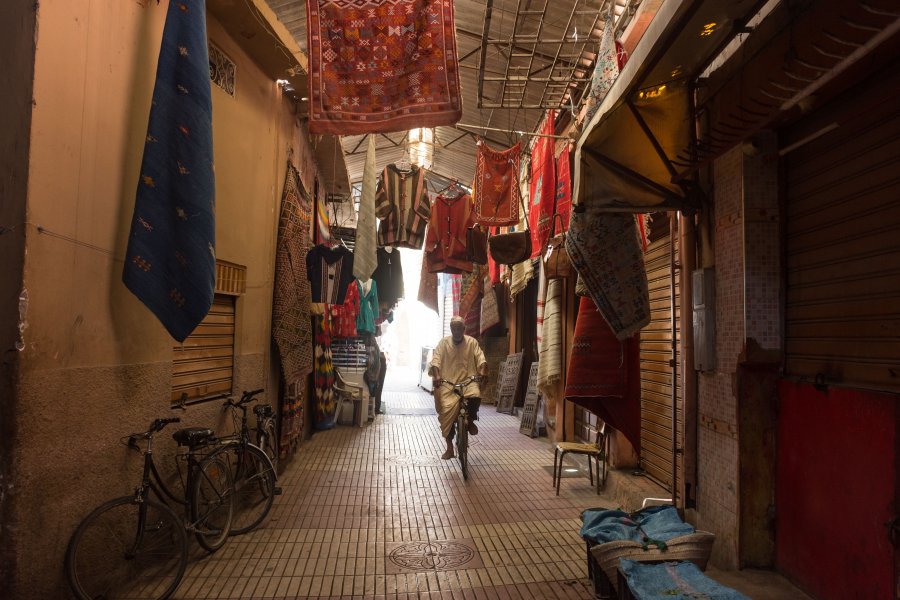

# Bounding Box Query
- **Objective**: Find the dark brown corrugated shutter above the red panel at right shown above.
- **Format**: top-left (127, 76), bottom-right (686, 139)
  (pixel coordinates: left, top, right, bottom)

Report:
top-left (782, 88), bottom-right (900, 391)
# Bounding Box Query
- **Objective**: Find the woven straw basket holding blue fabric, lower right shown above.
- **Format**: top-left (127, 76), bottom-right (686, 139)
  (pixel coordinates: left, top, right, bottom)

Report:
top-left (591, 531), bottom-right (716, 587)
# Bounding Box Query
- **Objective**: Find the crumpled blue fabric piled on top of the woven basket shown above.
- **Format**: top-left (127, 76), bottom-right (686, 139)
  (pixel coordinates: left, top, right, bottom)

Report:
top-left (580, 506), bottom-right (694, 544)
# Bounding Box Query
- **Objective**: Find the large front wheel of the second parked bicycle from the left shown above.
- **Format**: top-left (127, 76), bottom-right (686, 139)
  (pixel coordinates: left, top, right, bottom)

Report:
top-left (215, 443), bottom-right (275, 535)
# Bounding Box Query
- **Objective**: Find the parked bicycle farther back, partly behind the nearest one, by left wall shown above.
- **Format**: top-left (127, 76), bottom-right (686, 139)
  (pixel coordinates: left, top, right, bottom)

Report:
top-left (210, 389), bottom-right (281, 535)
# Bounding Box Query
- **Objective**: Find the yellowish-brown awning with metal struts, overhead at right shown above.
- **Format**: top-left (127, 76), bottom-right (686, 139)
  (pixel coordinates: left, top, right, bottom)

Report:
top-left (573, 0), bottom-right (762, 212)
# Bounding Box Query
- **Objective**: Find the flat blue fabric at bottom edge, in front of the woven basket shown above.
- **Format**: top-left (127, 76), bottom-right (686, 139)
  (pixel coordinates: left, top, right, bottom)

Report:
top-left (619, 558), bottom-right (750, 600)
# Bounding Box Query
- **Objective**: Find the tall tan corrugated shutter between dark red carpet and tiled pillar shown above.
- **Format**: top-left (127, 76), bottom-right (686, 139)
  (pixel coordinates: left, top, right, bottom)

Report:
top-left (640, 214), bottom-right (684, 491)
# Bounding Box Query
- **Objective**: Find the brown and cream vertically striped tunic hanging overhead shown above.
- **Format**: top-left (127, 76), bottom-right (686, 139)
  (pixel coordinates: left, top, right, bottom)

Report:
top-left (375, 165), bottom-right (431, 250)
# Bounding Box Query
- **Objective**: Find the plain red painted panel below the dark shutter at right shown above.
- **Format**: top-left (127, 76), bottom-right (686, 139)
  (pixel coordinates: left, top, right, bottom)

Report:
top-left (775, 381), bottom-right (900, 599)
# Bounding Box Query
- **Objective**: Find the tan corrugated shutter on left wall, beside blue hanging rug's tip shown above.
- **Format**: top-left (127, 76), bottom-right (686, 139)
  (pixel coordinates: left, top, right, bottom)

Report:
top-left (172, 294), bottom-right (234, 403)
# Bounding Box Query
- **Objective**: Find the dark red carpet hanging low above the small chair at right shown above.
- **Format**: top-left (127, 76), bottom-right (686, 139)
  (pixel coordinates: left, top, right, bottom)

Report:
top-left (568, 298), bottom-right (641, 452)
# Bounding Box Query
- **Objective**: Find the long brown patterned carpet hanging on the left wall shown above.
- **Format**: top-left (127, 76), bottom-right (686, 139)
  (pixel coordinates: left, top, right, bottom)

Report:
top-left (272, 164), bottom-right (313, 382)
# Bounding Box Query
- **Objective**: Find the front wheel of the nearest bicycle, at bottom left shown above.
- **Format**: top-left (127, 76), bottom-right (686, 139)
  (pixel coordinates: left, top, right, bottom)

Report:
top-left (65, 496), bottom-right (188, 600)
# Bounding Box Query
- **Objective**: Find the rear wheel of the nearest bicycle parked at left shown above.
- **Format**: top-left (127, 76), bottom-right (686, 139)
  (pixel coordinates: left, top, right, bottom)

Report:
top-left (190, 453), bottom-right (234, 552)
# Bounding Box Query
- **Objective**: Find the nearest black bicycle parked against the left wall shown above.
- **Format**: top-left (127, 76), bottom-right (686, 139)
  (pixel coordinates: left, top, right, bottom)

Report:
top-left (65, 417), bottom-right (234, 600)
